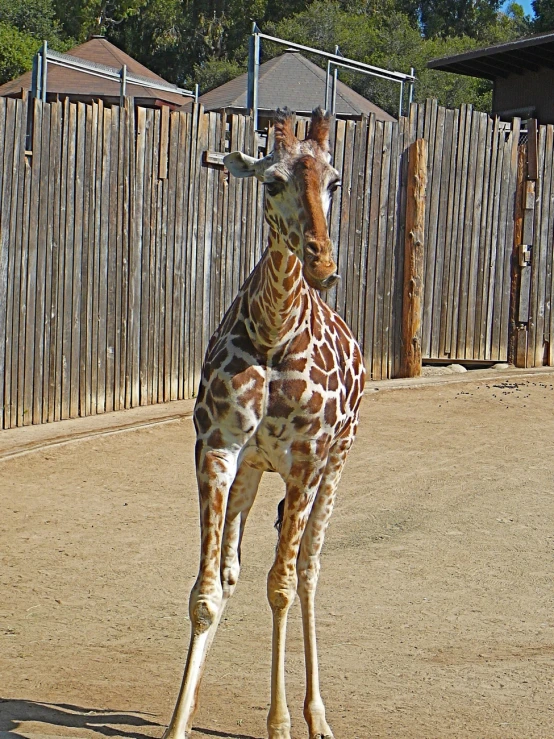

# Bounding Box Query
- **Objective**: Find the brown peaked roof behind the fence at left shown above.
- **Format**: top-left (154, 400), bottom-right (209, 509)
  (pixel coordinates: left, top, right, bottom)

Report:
top-left (0, 36), bottom-right (191, 107)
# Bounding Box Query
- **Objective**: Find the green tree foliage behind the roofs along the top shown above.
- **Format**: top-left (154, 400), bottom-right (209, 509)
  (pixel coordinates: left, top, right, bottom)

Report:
top-left (0, 0), bottom-right (536, 113)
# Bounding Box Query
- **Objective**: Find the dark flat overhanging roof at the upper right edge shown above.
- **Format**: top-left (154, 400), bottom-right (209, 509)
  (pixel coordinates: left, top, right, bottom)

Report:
top-left (427, 32), bottom-right (554, 80)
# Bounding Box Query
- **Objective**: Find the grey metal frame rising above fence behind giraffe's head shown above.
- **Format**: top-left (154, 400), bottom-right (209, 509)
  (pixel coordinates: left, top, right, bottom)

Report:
top-left (247, 23), bottom-right (416, 130)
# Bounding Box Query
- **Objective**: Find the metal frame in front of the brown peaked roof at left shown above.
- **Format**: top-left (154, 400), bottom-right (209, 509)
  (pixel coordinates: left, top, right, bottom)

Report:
top-left (31, 41), bottom-right (198, 105)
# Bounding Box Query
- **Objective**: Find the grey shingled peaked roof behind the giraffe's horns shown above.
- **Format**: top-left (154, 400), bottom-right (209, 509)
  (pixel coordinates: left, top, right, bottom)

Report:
top-left (188, 51), bottom-right (395, 121)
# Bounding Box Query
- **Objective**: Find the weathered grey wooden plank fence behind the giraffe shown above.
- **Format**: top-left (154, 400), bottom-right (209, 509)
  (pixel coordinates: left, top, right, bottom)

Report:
top-left (0, 98), bottom-right (554, 428)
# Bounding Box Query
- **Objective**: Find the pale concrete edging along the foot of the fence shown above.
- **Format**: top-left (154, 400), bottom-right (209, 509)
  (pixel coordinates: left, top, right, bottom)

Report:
top-left (0, 367), bottom-right (554, 462)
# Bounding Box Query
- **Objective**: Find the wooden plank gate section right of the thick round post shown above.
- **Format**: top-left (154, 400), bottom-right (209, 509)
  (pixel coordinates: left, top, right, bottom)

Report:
top-left (412, 101), bottom-right (520, 362)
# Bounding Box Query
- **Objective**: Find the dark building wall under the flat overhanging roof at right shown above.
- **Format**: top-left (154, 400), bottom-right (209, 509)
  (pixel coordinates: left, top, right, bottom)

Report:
top-left (492, 69), bottom-right (554, 124)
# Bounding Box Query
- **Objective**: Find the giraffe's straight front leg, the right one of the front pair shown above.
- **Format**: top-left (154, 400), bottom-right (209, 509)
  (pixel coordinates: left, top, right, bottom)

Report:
top-left (267, 472), bottom-right (321, 739)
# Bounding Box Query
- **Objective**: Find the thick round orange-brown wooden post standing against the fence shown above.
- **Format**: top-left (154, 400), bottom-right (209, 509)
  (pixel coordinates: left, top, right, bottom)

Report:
top-left (399, 139), bottom-right (427, 377)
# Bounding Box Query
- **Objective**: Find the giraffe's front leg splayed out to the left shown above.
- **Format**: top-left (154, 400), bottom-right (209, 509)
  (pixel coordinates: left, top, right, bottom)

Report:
top-left (164, 444), bottom-right (237, 739)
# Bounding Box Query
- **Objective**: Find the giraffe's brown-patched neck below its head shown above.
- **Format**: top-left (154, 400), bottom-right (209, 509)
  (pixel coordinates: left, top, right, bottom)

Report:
top-left (248, 228), bottom-right (310, 351)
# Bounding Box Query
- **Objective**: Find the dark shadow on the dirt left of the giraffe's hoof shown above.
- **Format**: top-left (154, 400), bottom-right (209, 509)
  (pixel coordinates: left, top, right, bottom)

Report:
top-left (0, 698), bottom-right (161, 739)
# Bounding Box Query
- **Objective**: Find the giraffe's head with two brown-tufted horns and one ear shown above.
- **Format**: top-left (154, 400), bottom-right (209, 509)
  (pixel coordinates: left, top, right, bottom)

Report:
top-left (224, 108), bottom-right (340, 290)
